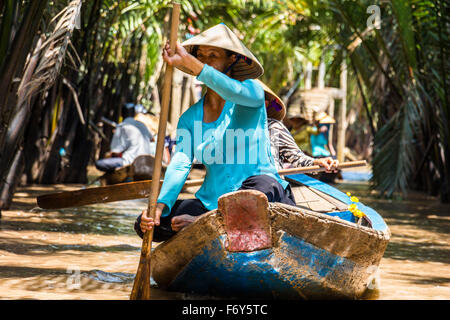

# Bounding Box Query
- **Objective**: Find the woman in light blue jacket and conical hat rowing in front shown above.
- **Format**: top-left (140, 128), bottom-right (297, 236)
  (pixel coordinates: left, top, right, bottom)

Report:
top-left (135, 24), bottom-right (295, 241)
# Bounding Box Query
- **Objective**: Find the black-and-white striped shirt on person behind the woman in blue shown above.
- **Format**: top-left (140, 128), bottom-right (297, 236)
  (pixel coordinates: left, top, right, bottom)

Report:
top-left (267, 118), bottom-right (314, 170)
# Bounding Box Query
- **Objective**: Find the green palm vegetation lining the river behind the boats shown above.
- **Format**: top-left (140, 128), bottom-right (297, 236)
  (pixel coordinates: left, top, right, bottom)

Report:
top-left (0, 0), bottom-right (450, 208)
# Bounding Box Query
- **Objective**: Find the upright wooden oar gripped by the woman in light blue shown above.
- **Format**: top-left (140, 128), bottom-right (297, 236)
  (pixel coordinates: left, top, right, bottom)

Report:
top-left (130, 2), bottom-right (180, 300)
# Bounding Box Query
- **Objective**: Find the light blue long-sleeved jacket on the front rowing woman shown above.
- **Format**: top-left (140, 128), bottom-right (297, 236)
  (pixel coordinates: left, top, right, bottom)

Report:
top-left (158, 64), bottom-right (288, 216)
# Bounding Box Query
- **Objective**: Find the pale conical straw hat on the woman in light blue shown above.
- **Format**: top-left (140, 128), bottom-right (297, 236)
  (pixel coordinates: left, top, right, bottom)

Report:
top-left (181, 23), bottom-right (264, 81)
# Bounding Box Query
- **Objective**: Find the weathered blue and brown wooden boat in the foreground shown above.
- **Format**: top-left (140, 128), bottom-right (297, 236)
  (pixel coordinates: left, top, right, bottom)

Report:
top-left (151, 174), bottom-right (390, 299)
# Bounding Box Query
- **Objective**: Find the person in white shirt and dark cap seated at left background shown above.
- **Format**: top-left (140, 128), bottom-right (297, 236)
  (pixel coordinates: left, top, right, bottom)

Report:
top-left (95, 103), bottom-right (153, 172)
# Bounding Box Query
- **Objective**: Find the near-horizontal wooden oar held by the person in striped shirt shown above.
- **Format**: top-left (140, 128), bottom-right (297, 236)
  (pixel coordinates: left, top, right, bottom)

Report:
top-left (37, 160), bottom-right (367, 209)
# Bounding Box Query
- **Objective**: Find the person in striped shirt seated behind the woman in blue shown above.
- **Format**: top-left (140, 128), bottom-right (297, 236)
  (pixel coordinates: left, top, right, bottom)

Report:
top-left (257, 80), bottom-right (339, 172)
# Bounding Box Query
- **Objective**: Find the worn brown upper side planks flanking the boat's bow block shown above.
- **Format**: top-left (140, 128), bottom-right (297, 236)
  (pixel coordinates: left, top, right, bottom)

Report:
top-left (151, 195), bottom-right (390, 287)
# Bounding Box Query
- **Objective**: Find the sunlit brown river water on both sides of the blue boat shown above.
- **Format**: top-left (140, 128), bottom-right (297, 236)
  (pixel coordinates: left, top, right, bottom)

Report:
top-left (0, 182), bottom-right (450, 299)
